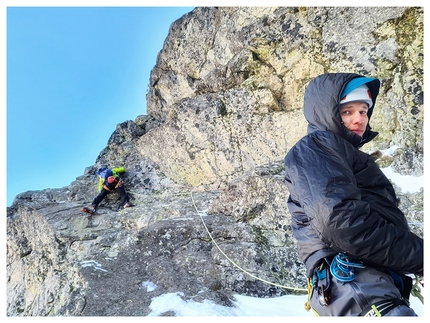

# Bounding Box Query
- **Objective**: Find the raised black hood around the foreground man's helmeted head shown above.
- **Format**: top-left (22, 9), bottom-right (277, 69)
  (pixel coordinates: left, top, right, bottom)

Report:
top-left (304, 73), bottom-right (380, 147)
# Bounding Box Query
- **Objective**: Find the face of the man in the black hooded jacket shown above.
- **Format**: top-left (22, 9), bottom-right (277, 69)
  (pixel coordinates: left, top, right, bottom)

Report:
top-left (340, 102), bottom-right (369, 137)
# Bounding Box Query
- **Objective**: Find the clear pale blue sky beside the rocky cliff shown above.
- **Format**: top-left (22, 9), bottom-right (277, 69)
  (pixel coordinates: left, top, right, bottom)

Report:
top-left (6, 6), bottom-right (193, 206)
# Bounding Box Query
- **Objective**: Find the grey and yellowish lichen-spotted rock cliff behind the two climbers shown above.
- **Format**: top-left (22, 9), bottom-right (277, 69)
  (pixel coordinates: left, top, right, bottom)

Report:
top-left (7, 7), bottom-right (424, 316)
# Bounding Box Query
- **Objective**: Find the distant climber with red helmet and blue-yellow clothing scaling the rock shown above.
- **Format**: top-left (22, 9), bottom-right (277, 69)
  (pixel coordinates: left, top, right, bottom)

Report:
top-left (82, 166), bottom-right (131, 214)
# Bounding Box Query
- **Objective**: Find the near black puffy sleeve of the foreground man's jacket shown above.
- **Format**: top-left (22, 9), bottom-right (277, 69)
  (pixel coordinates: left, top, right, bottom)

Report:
top-left (286, 132), bottom-right (423, 274)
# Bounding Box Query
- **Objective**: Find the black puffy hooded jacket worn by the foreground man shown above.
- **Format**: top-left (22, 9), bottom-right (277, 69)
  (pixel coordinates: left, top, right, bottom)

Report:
top-left (285, 73), bottom-right (423, 277)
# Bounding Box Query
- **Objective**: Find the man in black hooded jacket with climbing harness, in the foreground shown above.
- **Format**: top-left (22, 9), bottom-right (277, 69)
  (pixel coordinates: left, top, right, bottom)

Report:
top-left (284, 73), bottom-right (423, 316)
